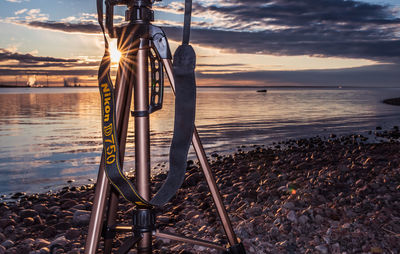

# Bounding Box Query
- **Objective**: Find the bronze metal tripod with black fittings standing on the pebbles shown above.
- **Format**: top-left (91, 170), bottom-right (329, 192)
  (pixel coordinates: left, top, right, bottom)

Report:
top-left (85, 0), bottom-right (245, 254)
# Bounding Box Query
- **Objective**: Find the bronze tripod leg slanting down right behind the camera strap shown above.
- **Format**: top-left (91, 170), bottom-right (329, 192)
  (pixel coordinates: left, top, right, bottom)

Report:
top-left (163, 59), bottom-right (238, 246)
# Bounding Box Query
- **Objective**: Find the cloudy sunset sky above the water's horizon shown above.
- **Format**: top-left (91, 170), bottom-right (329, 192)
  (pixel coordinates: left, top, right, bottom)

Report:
top-left (0, 0), bottom-right (400, 87)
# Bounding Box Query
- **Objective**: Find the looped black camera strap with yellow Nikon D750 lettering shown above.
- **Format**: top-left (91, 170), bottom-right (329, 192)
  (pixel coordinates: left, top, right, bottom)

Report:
top-left (97, 0), bottom-right (196, 207)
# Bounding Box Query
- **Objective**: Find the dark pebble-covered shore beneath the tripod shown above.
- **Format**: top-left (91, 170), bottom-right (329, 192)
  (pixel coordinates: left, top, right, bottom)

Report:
top-left (0, 133), bottom-right (400, 254)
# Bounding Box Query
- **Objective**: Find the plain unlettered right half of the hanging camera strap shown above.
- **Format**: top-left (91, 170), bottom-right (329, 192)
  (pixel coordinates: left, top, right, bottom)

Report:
top-left (151, 0), bottom-right (196, 204)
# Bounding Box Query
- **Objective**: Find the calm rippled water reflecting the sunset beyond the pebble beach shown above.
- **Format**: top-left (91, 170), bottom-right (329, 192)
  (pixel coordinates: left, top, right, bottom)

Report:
top-left (0, 88), bottom-right (400, 195)
